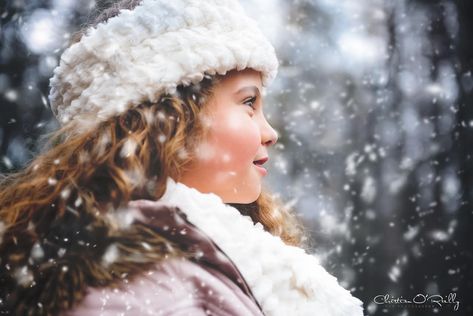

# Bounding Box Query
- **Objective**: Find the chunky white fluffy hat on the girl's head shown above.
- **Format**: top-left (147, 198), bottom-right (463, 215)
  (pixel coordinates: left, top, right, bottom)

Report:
top-left (49, 0), bottom-right (278, 129)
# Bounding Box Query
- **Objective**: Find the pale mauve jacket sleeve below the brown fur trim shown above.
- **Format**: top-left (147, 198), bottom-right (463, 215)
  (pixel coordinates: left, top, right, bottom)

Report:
top-left (64, 258), bottom-right (262, 316)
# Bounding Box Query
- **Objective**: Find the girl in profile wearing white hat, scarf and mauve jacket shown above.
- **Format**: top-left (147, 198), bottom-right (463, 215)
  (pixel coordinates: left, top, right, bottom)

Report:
top-left (0, 0), bottom-right (362, 316)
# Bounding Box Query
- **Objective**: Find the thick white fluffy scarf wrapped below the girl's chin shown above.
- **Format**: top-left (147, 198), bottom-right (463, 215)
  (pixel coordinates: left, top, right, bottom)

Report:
top-left (160, 178), bottom-right (363, 316)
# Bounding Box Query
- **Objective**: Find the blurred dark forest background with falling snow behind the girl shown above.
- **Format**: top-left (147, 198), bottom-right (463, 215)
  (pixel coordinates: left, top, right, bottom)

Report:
top-left (0, 0), bottom-right (473, 316)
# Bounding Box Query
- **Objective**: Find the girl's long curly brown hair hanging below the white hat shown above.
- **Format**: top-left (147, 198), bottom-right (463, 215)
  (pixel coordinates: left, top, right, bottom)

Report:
top-left (0, 0), bottom-right (307, 253)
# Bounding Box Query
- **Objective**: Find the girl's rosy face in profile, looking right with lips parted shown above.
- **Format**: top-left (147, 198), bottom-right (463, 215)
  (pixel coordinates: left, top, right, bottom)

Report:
top-left (178, 68), bottom-right (277, 204)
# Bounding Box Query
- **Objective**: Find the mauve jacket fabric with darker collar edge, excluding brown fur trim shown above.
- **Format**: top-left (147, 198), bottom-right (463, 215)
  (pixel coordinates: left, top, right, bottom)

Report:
top-left (63, 204), bottom-right (263, 316)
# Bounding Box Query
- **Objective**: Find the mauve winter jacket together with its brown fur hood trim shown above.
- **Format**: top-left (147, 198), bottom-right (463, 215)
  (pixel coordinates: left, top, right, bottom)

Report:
top-left (0, 201), bottom-right (261, 315)
